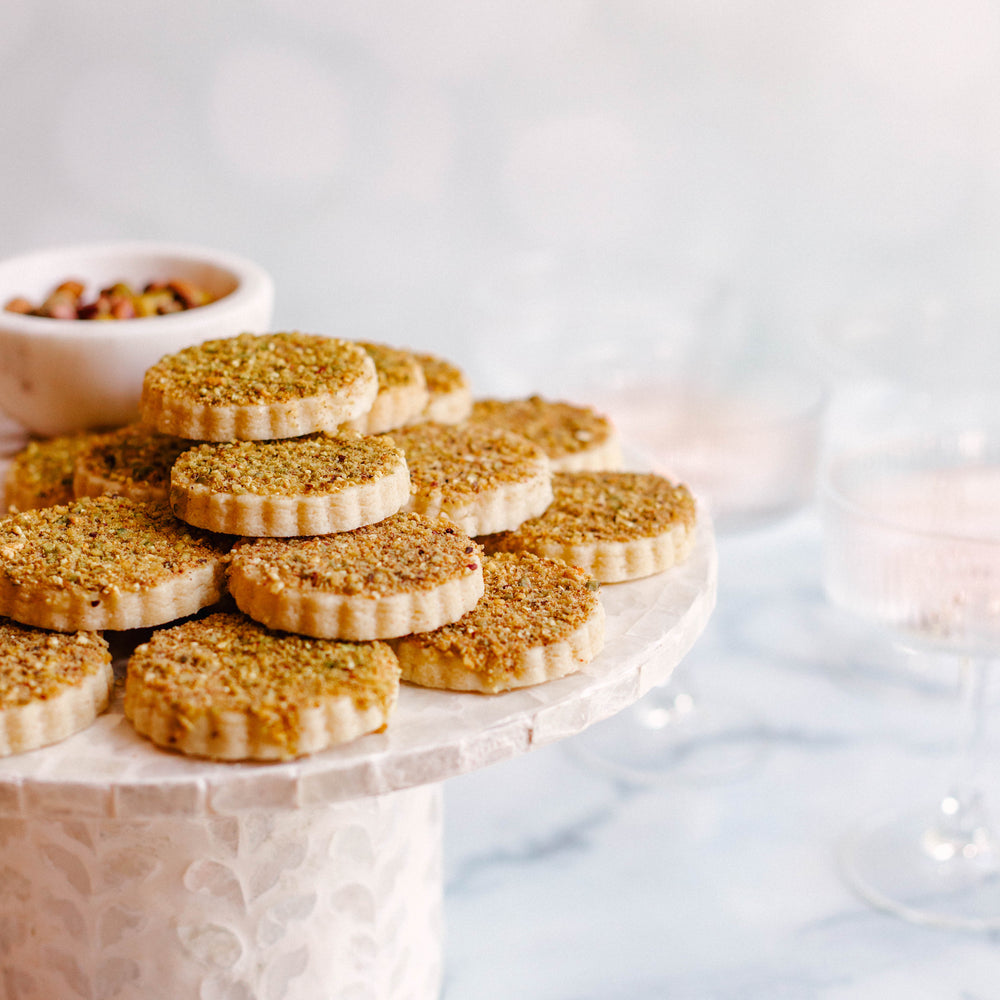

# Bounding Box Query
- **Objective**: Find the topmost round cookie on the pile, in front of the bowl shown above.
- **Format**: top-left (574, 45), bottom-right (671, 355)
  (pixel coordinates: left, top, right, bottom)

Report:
top-left (141, 333), bottom-right (378, 441)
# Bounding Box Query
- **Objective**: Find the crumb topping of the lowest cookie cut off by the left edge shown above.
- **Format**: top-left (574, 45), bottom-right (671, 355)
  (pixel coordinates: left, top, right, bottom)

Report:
top-left (0, 620), bottom-right (111, 711)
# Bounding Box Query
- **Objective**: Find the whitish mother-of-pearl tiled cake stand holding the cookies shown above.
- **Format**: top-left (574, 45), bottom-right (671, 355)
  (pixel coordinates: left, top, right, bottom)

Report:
top-left (0, 454), bottom-right (716, 1000)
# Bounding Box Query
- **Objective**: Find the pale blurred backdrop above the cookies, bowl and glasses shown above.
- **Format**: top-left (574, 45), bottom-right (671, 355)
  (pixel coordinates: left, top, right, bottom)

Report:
top-left (0, 0), bottom-right (1000, 390)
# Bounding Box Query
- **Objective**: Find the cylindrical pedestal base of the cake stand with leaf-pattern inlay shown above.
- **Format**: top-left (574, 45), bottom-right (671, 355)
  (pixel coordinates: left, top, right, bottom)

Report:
top-left (0, 784), bottom-right (443, 1000)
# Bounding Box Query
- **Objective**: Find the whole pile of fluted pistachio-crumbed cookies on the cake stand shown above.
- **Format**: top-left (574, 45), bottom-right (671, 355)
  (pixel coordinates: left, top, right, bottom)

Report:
top-left (0, 333), bottom-right (695, 760)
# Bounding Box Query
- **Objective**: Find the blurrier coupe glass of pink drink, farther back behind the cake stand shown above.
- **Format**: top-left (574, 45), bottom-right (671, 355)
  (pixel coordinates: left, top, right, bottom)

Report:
top-left (573, 292), bottom-right (826, 781)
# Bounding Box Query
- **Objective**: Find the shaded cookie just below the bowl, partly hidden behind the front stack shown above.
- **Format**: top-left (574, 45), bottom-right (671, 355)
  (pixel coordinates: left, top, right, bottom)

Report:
top-left (73, 424), bottom-right (194, 501)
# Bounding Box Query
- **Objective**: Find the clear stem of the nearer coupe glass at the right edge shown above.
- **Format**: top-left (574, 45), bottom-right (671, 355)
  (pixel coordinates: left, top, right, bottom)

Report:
top-left (925, 656), bottom-right (994, 861)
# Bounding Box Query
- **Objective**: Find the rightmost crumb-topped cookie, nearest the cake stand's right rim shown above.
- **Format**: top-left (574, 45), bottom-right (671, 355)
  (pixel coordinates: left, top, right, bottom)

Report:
top-left (480, 471), bottom-right (695, 583)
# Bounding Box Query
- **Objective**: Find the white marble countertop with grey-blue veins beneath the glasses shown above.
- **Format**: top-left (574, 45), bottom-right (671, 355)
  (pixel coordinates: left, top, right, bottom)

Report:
top-left (443, 509), bottom-right (1000, 1000)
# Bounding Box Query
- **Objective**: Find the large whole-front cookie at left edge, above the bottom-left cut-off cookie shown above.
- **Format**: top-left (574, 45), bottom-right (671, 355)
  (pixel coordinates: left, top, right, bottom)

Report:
top-left (0, 496), bottom-right (226, 632)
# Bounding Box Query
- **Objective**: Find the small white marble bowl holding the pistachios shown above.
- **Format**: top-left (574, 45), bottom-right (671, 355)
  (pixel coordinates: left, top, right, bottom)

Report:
top-left (0, 242), bottom-right (274, 435)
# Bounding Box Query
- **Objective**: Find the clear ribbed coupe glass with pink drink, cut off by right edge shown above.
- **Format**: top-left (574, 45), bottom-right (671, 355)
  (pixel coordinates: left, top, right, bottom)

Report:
top-left (820, 404), bottom-right (1000, 929)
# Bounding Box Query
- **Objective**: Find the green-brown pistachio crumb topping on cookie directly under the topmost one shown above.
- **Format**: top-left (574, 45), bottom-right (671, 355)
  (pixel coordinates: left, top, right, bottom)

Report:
top-left (172, 431), bottom-right (405, 496)
